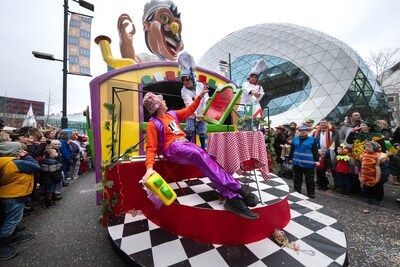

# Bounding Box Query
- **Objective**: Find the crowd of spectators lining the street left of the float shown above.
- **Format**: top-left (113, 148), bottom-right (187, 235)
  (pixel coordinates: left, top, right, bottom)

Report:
top-left (0, 119), bottom-right (90, 260)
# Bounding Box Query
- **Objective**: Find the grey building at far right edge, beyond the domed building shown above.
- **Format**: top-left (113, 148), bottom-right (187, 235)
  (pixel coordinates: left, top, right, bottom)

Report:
top-left (381, 62), bottom-right (400, 125)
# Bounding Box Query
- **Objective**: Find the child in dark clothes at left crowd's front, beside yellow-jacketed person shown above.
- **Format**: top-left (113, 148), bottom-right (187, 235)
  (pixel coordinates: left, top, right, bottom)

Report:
top-left (39, 148), bottom-right (62, 208)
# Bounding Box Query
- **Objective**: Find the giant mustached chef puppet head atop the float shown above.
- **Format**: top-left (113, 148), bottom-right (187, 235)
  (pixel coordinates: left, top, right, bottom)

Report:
top-left (142, 0), bottom-right (183, 61)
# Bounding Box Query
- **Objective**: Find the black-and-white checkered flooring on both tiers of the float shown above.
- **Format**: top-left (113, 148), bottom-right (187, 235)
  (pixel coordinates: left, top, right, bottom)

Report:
top-left (108, 175), bottom-right (347, 267)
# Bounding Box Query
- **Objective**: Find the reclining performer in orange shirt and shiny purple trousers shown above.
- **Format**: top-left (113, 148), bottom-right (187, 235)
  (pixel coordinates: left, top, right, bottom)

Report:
top-left (142, 88), bottom-right (259, 219)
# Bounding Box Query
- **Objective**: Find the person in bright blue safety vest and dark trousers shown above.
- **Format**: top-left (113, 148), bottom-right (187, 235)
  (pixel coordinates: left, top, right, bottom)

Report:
top-left (289, 124), bottom-right (319, 198)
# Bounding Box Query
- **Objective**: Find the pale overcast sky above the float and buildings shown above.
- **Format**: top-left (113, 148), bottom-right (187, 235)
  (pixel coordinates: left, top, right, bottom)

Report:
top-left (0, 0), bottom-right (400, 113)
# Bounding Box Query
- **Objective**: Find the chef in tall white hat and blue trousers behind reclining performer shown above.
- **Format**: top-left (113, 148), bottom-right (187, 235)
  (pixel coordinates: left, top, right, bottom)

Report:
top-left (178, 52), bottom-right (209, 149)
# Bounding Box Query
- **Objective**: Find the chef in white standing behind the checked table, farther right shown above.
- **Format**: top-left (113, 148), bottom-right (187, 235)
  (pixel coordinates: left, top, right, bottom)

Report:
top-left (238, 59), bottom-right (267, 116)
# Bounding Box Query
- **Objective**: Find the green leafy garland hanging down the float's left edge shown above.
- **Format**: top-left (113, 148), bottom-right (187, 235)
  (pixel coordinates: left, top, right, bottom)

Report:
top-left (96, 103), bottom-right (139, 226)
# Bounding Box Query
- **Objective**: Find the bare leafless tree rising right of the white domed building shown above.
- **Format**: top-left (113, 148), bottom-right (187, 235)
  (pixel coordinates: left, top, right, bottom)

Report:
top-left (368, 47), bottom-right (400, 85)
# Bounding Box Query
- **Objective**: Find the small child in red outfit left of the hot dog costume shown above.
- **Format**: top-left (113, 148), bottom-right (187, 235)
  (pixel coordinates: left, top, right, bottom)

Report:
top-left (335, 144), bottom-right (351, 196)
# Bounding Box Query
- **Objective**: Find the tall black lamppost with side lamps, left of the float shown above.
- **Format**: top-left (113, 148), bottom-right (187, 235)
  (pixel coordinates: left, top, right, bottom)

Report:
top-left (32, 0), bottom-right (94, 129)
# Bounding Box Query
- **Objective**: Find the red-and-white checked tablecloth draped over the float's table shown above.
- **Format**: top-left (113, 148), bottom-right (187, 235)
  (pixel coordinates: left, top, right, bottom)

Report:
top-left (207, 131), bottom-right (269, 179)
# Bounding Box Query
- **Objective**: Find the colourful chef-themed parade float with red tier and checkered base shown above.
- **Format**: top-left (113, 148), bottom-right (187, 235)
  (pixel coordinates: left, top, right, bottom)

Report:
top-left (90, 0), bottom-right (346, 266)
